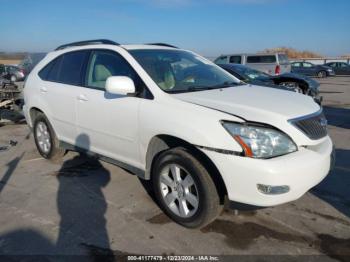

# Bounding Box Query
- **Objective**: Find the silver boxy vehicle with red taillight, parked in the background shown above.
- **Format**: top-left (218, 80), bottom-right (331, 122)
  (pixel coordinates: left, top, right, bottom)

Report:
top-left (214, 53), bottom-right (291, 75)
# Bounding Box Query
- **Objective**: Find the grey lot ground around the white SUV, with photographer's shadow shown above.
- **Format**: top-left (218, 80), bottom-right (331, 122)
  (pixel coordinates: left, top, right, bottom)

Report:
top-left (0, 77), bottom-right (350, 261)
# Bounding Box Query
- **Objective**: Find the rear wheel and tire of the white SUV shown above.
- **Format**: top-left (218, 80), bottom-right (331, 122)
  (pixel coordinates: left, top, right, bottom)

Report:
top-left (33, 113), bottom-right (65, 162)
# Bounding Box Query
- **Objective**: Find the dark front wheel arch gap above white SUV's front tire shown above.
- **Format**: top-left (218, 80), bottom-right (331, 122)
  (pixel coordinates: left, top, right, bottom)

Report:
top-left (145, 134), bottom-right (227, 203)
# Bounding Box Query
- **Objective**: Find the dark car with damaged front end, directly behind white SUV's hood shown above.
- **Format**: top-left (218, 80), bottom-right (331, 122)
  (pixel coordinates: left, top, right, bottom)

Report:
top-left (220, 64), bottom-right (320, 103)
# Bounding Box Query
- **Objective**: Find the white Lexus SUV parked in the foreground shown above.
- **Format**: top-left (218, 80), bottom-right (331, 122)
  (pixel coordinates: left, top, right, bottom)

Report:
top-left (24, 40), bottom-right (333, 227)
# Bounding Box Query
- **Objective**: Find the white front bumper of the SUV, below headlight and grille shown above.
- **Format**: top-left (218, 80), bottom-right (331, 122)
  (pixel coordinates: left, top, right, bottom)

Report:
top-left (201, 137), bottom-right (333, 206)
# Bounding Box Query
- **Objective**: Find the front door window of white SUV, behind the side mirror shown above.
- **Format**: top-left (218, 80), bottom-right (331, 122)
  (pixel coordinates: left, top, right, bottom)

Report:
top-left (85, 50), bottom-right (144, 91)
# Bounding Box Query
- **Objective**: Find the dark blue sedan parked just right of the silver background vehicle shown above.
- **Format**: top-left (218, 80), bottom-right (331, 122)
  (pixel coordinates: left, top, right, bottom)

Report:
top-left (292, 62), bottom-right (335, 78)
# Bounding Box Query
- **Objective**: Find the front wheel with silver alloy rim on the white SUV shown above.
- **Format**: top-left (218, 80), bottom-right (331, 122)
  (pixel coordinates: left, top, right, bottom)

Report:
top-left (152, 148), bottom-right (222, 228)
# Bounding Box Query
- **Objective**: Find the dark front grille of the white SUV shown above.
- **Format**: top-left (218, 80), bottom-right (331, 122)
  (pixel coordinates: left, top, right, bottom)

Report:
top-left (290, 111), bottom-right (327, 140)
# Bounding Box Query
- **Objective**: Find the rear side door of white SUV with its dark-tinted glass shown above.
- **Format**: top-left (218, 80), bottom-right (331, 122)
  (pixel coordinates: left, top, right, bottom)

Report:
top-left (39, 51), bottom-right (88, 144)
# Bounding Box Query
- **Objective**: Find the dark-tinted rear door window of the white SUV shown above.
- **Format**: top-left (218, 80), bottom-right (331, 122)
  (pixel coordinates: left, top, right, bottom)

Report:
top-left (58, 51), bottom-right (89, 85)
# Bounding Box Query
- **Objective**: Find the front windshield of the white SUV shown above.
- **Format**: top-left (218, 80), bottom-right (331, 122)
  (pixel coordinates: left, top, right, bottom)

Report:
top-left (130, 49), bottom-right (240, 93)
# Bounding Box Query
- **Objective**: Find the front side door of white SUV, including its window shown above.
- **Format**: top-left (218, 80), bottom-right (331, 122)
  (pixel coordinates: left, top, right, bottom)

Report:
top-left (76, 50), bottom-right (140, 166)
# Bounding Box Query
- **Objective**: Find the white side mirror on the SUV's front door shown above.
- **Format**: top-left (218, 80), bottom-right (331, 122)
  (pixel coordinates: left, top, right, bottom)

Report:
top-left (106, 76), bottom-right (136, 96)
